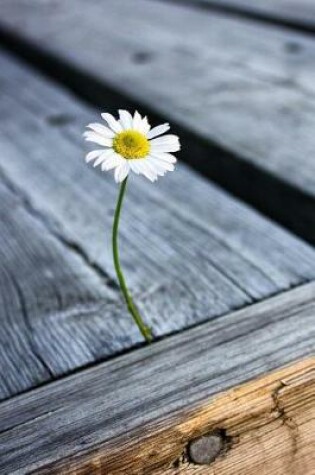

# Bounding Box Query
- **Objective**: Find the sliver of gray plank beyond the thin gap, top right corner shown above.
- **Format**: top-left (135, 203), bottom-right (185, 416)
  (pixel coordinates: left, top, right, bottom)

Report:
top-left (175, 0), bottom-right (315, 33)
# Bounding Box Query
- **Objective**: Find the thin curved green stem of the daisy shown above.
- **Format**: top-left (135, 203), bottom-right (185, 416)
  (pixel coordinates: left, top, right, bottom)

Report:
top-left (113, 177), bottom-right (153, 343)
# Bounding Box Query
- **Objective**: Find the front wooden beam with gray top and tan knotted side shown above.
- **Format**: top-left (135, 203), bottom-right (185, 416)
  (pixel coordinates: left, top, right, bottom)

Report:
top-left (0, 283), bottom-right (315, 475)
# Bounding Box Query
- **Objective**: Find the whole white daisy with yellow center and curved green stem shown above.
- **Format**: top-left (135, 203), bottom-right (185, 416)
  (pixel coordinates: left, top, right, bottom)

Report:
top-left (84, 110), bottom-right (180, 343)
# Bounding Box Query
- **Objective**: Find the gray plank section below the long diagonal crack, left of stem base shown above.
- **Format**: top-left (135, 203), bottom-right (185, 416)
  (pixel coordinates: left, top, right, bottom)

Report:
top-left (0, 172), bottom-right (139, 399)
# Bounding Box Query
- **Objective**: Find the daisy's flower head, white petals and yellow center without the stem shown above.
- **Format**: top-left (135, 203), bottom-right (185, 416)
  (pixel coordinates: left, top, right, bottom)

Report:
top-left (84, 110), bottom-right (180, 183)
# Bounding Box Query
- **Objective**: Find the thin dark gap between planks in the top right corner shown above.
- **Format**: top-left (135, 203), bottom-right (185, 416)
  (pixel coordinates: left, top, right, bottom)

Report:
top-left (157, 0), bottom-right (315, 35)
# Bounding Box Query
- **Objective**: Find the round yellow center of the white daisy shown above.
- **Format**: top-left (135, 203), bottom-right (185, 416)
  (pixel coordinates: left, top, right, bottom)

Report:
top-left (113, 130), bottom-right (150, 160)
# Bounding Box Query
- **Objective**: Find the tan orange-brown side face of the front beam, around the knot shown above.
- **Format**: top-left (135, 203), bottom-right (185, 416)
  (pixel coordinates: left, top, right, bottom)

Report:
top-left (54, 358), bottom-right (315, 475)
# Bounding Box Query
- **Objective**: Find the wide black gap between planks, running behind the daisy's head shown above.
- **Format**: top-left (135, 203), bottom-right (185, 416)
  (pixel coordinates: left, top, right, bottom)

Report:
top-left (0, 23), bottom-right (315, 249)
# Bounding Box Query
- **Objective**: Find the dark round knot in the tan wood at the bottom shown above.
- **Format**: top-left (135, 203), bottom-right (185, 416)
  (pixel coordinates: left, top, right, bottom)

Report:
top-left (188, 432), bottom-right (224, 465)
